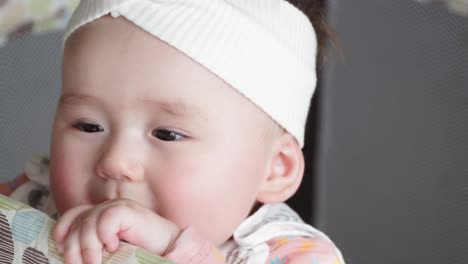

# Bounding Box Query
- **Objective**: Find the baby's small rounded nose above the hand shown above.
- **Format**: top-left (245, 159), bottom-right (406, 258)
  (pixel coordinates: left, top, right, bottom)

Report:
top-left (96, 140), bottom-right (144, 181)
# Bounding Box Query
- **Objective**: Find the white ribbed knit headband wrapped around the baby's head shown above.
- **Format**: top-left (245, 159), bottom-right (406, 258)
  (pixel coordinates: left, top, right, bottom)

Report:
top-left (64, 0), bottom-right (317, 147)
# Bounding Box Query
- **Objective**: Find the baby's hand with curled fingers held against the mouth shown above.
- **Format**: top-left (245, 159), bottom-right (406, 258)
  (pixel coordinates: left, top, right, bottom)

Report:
top-left (53, 199), bottom-right (180, 263)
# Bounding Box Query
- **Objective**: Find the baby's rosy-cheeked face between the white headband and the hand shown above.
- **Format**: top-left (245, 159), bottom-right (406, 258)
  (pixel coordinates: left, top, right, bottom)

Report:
top-left (51, 16), bottom-right (278, 243)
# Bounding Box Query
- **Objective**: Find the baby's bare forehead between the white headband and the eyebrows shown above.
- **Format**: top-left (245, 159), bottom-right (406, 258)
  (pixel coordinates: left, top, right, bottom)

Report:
top-left (63, 36), bottom-right (264, 120)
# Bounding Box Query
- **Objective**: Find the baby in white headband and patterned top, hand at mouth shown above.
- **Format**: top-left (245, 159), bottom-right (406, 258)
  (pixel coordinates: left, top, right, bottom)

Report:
top-left (2, 0), bottom-right (344, 264)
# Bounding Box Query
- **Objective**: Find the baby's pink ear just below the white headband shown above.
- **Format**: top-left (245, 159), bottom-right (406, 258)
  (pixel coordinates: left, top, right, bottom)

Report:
top-left (257, 132), bottom-right (304, 203)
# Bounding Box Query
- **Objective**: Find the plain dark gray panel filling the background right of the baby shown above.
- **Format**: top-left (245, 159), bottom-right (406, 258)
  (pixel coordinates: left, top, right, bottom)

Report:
top-left (314, 0), bottom-right (468, 264)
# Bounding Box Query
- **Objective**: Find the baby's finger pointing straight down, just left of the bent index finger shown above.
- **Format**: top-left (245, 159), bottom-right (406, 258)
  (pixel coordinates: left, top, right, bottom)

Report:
top-left (80, 216), bottom-right (102, 264)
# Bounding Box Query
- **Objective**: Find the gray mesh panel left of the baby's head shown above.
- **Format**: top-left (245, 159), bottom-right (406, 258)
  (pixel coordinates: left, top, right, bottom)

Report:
top-left (0, 32), bottom-right (61, 180)
